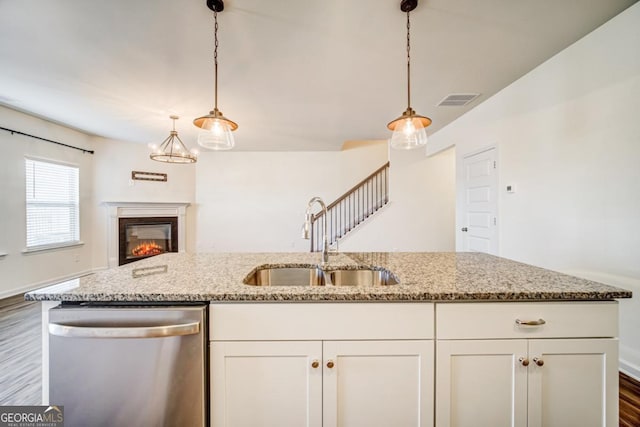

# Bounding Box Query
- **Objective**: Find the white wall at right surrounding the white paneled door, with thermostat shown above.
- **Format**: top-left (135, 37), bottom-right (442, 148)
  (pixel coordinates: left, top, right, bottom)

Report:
top-left (431, 4), bottom-right (640, 376)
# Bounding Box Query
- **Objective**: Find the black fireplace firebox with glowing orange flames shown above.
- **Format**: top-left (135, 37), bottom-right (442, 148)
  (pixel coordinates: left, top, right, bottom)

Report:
top-left (118, 217), bottom-right (178, 265)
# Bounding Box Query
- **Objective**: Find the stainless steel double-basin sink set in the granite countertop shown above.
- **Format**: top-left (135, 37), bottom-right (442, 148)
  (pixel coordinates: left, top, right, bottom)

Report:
top-left (244, 266), bottom-right (399, 286)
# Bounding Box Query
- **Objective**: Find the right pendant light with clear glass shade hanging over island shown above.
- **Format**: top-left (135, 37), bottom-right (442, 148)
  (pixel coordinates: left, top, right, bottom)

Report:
top-left (387, 0), bottom-right (431, 150)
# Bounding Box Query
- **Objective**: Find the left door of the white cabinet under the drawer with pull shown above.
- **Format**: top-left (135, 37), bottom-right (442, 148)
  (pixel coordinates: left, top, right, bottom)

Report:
top-left (436, 340), bottom-right (527, 427)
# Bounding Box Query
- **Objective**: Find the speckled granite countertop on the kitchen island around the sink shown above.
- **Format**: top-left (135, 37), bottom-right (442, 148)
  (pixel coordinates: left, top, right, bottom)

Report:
top-left (25, 252), bottom-right (631, 302)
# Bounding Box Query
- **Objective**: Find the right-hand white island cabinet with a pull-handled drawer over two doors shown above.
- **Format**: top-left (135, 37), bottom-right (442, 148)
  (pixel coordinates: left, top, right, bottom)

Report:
top-left (436, 302), bottom-right (618, 427)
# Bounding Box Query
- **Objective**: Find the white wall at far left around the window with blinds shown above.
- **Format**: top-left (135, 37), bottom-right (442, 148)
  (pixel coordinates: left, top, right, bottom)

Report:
top-left (0, 107), bottom-right (94, 299)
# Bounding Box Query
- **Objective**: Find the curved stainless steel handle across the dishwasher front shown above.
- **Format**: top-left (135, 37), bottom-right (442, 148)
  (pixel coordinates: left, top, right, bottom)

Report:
top-left (49, 322), bottom-right (200, 338)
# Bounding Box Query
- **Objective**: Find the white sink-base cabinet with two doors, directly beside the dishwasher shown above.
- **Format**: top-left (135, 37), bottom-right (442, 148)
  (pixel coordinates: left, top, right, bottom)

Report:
top-left (210, 304), bottom-right (434, 427)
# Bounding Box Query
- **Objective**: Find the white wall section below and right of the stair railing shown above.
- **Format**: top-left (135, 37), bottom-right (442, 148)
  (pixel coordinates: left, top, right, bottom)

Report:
top-left (339, 148), bottom-right (455, 252)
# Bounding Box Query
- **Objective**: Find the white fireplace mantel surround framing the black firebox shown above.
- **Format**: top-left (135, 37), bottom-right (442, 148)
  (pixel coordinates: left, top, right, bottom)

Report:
top-left (102, 202), bottom-right (190, 268)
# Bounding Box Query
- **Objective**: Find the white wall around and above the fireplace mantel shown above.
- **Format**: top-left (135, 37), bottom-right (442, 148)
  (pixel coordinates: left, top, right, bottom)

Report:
top-left (93, 138), bottom-right (198, 268)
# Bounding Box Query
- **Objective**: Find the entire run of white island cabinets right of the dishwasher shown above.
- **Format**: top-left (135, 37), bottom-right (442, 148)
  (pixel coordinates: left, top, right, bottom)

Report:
top-left (209, 301), bottom-right (618, 427)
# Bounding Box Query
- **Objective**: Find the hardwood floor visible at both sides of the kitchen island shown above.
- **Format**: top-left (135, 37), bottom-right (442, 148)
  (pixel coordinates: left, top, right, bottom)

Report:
top-left (0, 295), bottom-right (640, 427)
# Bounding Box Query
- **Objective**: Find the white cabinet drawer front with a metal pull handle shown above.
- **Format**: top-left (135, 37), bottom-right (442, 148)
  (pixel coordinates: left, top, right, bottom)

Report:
top-left (436, 301), bottom-right (618, 339)
